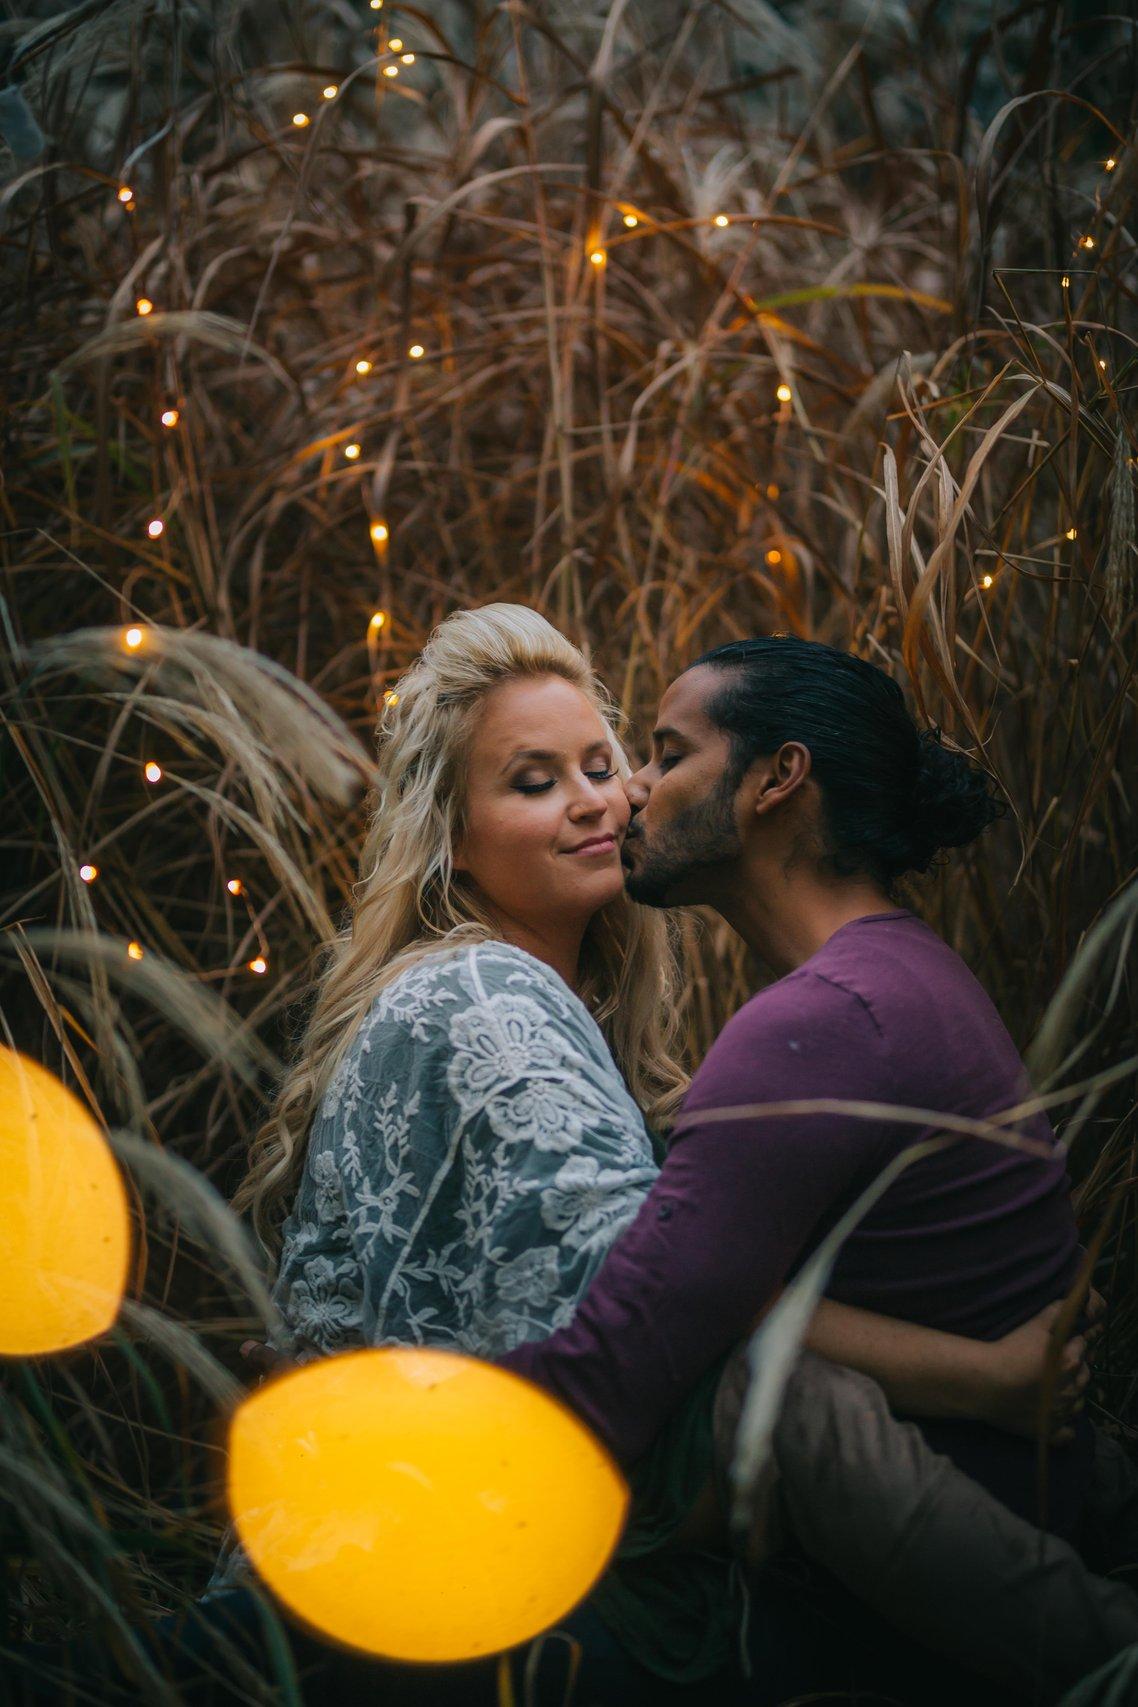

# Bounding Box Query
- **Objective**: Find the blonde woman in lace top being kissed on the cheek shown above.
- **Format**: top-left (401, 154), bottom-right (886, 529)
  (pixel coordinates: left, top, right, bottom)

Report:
top-left (235, 604), bottom-right (1132, 1700)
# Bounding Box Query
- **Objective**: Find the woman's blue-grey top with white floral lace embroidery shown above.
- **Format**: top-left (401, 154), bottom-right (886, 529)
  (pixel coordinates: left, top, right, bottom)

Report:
top-left (275, 942), bottom-right (657, 1357)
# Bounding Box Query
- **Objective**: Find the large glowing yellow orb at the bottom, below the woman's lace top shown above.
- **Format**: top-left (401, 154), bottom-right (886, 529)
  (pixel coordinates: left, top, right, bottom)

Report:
top-left (229, 1347), bottom-right (628, 1661)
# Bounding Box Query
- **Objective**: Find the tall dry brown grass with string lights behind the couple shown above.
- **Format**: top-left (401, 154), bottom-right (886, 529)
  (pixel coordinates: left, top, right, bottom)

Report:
top-left (0, 0), bottom-right (1138, 1698)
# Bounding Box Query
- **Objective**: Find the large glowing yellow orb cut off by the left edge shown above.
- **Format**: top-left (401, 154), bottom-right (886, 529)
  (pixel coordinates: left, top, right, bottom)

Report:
top-left (0, 1046), bottom-right (130, 1357)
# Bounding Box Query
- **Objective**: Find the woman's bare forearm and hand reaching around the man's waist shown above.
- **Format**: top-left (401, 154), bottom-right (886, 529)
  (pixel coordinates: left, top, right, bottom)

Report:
top-left (805, 1299), bottom-right (1089, 1441)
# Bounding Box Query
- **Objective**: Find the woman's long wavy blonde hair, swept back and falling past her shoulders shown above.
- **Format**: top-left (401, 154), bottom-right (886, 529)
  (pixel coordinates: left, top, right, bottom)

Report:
top-left (234, 604), bottom-right (688, 1256)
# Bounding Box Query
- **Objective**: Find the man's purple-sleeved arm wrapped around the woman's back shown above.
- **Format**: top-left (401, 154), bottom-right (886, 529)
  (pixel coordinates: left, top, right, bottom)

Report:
top-left (500, 975), bottom-right (896, 1465)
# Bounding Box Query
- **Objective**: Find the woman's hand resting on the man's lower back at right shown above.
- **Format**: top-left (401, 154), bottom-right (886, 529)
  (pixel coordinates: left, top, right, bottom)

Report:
top-left (984, 1292), bottom-right (1106, 1446)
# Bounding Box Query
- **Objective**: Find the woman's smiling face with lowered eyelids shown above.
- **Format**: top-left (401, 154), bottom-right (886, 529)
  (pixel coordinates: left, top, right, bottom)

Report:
top-left (456, 676), bottom-right (631, 930)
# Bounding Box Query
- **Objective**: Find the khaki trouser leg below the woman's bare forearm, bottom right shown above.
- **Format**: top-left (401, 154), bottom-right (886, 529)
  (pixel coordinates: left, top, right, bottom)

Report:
top-left (715, 1349), bottom-right (1138, 1702)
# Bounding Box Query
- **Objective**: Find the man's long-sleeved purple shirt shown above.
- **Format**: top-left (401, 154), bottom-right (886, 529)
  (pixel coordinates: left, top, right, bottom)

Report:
top-left (500, 912), bottom-right (1083, 1529)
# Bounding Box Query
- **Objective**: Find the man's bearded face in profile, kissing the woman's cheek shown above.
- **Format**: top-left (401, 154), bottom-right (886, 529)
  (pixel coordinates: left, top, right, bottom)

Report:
top-left (621, 664), bottom-right (742, 906)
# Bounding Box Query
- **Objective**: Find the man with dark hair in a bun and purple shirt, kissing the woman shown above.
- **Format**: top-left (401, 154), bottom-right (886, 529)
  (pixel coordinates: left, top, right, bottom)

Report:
top-left (500, 638), bottom-right (1133, 1698)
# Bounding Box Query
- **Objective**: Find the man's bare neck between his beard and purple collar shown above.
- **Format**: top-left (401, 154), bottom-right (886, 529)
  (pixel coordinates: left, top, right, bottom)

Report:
top-left (711, 865), bottom-right (896, 978)
